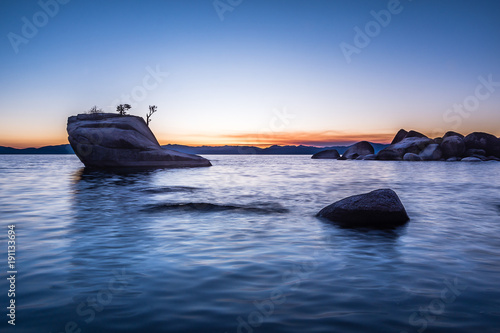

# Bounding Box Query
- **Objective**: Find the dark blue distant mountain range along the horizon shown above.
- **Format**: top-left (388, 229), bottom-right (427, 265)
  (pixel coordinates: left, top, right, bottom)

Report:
top-left (0, 143), bottom-right (388, 155)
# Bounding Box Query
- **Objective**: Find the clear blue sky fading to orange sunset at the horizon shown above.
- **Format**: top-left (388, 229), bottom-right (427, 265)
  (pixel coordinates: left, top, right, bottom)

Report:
top-left (0, 0), bottom-right (500, 147)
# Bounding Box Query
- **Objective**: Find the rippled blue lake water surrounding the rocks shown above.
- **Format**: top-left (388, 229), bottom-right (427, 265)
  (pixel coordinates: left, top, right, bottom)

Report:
top-left (0, 155), bottom-right (500, 333)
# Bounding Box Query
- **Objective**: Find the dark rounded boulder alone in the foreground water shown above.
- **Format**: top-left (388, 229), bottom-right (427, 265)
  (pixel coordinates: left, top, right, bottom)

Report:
top-left (316, 189), bottom-right (409, 228)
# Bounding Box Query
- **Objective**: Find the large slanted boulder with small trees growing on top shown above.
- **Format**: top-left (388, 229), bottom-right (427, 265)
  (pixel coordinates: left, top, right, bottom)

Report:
top-left (67, 113), bottom-right (211, 168)
